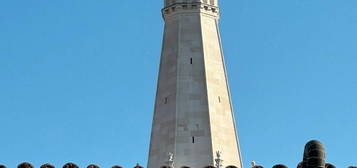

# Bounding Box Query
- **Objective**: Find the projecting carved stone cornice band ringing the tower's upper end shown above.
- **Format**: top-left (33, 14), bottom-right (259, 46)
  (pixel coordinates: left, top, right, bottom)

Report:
top-left (161, 2), bottom-right (219, 20)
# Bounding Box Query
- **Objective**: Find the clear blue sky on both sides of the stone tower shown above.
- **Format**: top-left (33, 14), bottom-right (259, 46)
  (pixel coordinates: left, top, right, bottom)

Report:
top-left (0, 0), bottom-right (357, 167)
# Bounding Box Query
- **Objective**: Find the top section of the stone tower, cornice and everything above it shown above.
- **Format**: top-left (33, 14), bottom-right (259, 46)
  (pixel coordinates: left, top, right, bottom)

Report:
top-left (162, 0), bottom-right (219, 20)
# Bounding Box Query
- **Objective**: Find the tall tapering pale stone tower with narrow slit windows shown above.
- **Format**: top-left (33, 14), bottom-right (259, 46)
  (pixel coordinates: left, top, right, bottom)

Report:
top-left (148, 0), bottom-right (242, 168)
